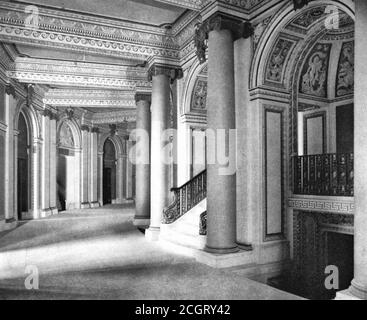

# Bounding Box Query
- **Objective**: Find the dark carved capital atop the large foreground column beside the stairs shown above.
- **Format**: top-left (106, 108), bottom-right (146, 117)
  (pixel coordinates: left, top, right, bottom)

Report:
top-left (194, 12), bottom-right (254, 63)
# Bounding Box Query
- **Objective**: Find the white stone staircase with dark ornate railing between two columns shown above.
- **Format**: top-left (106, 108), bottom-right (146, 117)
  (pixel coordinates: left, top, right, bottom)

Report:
top-left (160, 171), bottom-right (206, 250)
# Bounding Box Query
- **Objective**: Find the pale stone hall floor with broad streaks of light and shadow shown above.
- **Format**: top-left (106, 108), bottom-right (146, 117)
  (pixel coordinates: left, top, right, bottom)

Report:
top-left (0, 205), bottom-right (299, 300)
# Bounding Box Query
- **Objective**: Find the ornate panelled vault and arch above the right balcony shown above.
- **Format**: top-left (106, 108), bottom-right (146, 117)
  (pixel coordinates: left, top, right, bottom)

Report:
top-left (251, 0), bottom-right (354, 94)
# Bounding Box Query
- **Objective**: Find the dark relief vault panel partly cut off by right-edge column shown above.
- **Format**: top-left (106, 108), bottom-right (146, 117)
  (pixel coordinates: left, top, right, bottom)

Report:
top-left (335, 41), bottom-right (354, 97)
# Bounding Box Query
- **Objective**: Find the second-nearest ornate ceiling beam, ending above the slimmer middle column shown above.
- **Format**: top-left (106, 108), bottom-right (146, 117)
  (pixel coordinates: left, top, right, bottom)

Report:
top-left (8, 58), bottom-right (151, 91)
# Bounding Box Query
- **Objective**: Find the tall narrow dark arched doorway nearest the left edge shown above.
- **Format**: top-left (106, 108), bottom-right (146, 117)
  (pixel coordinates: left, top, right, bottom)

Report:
top-left (17, 113), bottom-right (30, 220)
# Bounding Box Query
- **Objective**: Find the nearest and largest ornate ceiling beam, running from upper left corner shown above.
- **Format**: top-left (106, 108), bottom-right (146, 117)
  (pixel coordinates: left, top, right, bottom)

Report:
top-left (0, 2), bottom-right (179, 61)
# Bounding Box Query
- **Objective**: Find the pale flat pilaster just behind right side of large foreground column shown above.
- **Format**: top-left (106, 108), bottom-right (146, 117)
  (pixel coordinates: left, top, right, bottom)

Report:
top-left (234, 30), bottom-right (253, 250)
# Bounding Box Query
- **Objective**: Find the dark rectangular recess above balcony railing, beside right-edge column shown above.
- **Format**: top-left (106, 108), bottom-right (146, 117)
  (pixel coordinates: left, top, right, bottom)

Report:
top-left (336, 104), bottom-right (354, 153)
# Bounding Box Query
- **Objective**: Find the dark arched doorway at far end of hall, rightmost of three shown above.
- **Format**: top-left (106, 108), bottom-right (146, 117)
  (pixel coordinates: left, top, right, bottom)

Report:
top-left (103, 139), bottom-right (116, 204)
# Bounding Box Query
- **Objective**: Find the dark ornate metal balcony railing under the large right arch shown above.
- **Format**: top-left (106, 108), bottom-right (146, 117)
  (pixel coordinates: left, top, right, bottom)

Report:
top-left (293, 153), bottom-right (354, 197)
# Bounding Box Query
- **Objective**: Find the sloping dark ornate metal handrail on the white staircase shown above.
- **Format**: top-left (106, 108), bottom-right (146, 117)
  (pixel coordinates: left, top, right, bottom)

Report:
top-left (162, 170), bottom-right (206, 224)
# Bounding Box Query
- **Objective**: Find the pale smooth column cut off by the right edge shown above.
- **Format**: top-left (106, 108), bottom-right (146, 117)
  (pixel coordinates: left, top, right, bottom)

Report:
top-left (349, 0), bottom-right (367, 299)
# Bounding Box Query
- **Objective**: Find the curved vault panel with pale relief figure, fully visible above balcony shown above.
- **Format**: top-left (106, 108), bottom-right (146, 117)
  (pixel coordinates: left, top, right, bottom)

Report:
top-left (299, 43), bottom-right (331, 98)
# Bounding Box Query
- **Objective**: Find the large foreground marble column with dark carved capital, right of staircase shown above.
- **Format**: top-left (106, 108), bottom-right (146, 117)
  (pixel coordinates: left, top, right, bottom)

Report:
top-left (196, 12), bottom-right (251, 254)
